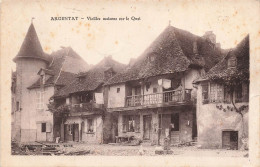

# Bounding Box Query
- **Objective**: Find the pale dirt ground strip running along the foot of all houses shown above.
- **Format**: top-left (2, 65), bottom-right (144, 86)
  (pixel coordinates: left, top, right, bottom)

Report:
top-left (12, 143), bottom-right (248, 158)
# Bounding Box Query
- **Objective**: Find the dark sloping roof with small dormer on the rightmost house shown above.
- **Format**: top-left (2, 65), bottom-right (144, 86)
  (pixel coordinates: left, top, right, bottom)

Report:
top-left (194, 35), bottom-right (249, 83)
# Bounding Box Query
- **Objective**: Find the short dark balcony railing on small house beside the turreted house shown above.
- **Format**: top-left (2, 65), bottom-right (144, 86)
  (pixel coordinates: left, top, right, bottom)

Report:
top-left (70, 102), bottom-right (104, 112)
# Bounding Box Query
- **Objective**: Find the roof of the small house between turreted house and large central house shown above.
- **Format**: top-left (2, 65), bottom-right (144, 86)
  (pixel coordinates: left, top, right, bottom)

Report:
top-left (54, 57), bottom-right (126, 98)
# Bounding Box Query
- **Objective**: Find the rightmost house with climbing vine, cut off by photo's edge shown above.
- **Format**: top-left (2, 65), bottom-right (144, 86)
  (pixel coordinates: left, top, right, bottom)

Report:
top-left (194, 36), bottom-right (249, 149)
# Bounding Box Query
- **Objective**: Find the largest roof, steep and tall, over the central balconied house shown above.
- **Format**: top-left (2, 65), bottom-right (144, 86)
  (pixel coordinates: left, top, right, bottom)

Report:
top-left (105, 26), bottom-right (222, 85)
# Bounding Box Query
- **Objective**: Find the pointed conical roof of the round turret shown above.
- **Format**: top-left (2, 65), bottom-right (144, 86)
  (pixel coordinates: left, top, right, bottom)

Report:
top-left (13, 23), bottom-right (50, 62)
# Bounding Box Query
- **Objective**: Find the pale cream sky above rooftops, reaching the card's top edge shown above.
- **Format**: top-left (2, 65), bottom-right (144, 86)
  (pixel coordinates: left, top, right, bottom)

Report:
top-left (1, 0), bottom-right (256, 70)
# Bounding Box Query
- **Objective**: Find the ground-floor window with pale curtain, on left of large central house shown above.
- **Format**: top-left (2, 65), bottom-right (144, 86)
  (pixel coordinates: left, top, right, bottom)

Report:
top-left (123, 115), bottom-right (140, 132)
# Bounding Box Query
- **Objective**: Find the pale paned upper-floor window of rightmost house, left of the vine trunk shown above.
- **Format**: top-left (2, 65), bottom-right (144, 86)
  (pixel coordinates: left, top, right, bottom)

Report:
top-left (210, 83), bottom-right (224, 102)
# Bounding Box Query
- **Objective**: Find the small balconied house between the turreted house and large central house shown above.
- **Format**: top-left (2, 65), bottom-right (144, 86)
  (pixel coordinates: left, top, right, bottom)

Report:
top-left (53, 56), bottom-right (125, 143)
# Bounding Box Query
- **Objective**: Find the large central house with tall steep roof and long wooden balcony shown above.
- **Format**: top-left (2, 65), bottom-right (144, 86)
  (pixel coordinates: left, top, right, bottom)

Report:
top-left (105, 26), bottom-right (222, 144)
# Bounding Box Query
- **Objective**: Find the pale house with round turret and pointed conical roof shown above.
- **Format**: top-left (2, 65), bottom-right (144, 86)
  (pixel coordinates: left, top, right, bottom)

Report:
top-left (12, 23), bottom-right (88, 142)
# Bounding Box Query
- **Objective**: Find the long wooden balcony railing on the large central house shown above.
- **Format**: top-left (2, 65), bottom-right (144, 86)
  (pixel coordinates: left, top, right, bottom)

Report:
top-left (125, 89), bottom-right (191, 107)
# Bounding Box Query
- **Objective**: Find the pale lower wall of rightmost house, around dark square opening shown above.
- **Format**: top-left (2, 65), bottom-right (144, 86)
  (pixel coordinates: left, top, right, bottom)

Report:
top-left (197, 83), bottom-right (248, 148)
